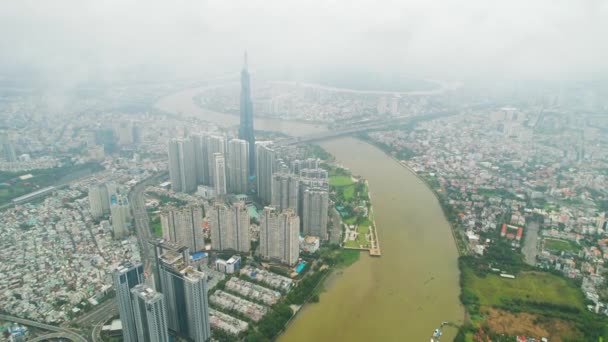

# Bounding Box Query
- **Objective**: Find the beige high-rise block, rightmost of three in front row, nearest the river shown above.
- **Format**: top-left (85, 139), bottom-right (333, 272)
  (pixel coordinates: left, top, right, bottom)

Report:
top-left (259, 207), bottom-right (300, 265)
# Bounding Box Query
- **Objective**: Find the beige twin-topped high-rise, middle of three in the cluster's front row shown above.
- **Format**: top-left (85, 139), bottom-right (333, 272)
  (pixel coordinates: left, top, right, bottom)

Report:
top-left (209, 201), bottom-right (251, 253)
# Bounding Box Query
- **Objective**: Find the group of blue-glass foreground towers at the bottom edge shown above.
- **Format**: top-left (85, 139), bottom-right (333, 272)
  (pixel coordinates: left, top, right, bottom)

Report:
top-left (114, 242), bottom-right (211, 342)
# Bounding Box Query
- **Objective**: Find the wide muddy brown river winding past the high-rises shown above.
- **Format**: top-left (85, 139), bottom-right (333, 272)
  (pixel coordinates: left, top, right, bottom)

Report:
top-left (157, 89), bottom-right (464, 342)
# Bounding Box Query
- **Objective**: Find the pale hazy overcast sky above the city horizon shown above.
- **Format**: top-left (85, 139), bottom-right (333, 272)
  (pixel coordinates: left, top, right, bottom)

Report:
top-left (0, 0), bottom-right (608, 82)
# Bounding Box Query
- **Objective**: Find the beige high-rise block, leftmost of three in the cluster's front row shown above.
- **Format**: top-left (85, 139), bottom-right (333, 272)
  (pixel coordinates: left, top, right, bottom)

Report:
top-left (160, 205), bottom-right (205, 252)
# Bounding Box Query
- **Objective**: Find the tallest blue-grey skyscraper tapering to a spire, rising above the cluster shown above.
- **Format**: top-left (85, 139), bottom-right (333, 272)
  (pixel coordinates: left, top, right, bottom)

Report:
top-left (239, 51), bottom-right (255, 177)
